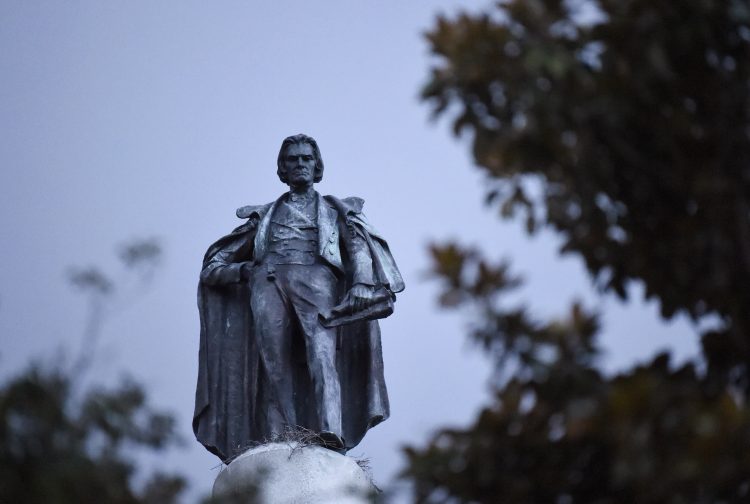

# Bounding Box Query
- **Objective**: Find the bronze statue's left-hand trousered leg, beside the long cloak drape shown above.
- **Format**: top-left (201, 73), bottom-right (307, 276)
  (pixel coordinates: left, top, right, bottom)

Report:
top-left (250, 268), bottom-right (297, 434)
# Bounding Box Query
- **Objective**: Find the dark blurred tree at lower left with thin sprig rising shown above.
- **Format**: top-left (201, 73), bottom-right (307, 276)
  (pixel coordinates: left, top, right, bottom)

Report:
top-left (0, 241), bottom-right (185, 504)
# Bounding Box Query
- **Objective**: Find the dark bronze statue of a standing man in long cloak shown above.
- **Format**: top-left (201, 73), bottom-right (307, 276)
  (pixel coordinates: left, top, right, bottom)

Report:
top-left (193, 135), bottom-right (404, 461)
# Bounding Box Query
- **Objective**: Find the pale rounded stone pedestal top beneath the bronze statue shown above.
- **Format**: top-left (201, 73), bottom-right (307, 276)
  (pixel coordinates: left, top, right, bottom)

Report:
top-left (213, 443), bottom-right (376, 504)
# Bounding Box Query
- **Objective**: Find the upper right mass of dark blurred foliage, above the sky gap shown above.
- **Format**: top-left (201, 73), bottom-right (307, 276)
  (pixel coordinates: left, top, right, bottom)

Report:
top-left (423, 0), bottom-right (750, 386)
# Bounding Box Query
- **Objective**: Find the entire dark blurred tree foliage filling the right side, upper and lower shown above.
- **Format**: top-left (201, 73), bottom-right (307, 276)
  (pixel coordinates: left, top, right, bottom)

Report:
top-left (405, 0), bottom-right (750, 503)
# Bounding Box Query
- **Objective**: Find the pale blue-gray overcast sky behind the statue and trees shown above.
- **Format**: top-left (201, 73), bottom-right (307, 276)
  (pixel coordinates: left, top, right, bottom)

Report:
top-left (0, 0), bottom-right (697, 500)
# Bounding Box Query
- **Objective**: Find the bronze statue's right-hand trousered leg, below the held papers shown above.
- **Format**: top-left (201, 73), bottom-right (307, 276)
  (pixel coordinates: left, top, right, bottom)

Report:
top-left (289, 264), bottom-right (342, 437)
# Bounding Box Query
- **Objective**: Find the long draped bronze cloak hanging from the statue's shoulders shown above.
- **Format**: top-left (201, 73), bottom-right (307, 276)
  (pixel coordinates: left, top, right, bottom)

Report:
top-left (193, 196), bottom-right (404, 462)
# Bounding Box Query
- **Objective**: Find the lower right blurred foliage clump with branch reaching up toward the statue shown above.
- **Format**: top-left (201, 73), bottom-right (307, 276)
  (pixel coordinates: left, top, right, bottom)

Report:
top-left (402, 244), bottom-right (750, 504)
